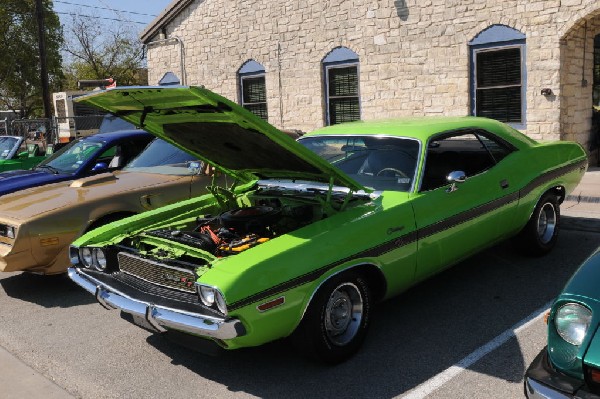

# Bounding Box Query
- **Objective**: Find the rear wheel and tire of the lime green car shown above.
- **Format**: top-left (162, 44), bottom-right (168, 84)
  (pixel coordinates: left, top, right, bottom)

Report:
top-left (516, 193), bottom-right (560, 256)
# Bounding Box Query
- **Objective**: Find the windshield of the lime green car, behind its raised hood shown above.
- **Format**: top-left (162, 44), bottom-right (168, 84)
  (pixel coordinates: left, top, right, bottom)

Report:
top-left (298, 136), bottom-right (419, 191)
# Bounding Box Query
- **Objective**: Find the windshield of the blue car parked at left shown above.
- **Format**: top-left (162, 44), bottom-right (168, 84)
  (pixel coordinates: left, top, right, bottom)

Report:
top-left (36, 140), bottom-right (104, 173)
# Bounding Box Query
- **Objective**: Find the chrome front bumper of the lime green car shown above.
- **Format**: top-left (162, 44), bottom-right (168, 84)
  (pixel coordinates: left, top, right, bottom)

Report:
top-left (68, 267), bottom-right (246, 340)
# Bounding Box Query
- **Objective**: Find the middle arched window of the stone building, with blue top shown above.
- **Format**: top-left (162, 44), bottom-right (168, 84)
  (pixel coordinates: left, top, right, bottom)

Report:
top-left (323, 47), bottom-right (360, 125)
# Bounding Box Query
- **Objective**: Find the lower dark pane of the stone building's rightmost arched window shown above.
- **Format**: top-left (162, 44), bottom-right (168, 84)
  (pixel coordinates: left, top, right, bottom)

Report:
top-left (476, 86), bottom-right (521, 122)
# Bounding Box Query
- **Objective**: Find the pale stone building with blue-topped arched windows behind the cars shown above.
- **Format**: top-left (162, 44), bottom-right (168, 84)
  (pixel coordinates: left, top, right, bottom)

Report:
top-left (141, 0), bottom-right (600, 162)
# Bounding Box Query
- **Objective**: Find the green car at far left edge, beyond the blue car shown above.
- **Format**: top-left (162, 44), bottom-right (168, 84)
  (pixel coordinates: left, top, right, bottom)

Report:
top-left (0, 136), bottom-right (49, 172)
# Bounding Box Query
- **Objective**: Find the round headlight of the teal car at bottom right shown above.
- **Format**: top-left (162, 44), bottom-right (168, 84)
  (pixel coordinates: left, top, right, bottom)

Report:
top-left (554, 303), bottom-right (592, 346)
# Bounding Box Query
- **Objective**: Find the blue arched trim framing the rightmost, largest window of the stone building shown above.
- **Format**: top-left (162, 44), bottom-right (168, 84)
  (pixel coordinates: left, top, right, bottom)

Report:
top-left (469, 25), bottom-right (527, 129)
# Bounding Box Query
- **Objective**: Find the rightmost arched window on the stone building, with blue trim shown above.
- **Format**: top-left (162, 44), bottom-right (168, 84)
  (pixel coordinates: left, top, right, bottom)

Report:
top-left (469, 25), bottom-right (526, 128)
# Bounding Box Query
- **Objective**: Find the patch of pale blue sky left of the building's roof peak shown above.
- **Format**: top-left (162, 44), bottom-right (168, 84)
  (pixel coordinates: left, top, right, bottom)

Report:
top-left (53, 0), bottom-right (172, 33)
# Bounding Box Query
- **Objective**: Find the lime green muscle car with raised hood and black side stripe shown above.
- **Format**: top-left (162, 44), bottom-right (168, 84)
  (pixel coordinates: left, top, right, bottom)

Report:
top-left (69, 87), bottom-right (587, 363)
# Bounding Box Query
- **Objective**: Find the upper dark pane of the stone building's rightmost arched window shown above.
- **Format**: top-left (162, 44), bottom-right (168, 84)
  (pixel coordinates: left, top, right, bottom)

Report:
top-left (477, 48), bottom-right (521, 88)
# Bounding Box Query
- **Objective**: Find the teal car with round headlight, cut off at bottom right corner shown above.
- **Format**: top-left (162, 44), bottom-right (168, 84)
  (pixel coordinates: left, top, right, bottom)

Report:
top-left (525, 248), bottom-right (600, 399)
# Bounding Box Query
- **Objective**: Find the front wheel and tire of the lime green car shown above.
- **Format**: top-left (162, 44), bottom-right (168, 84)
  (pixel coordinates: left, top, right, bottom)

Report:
top-left (292, 272), bottom-right (371, 364)
